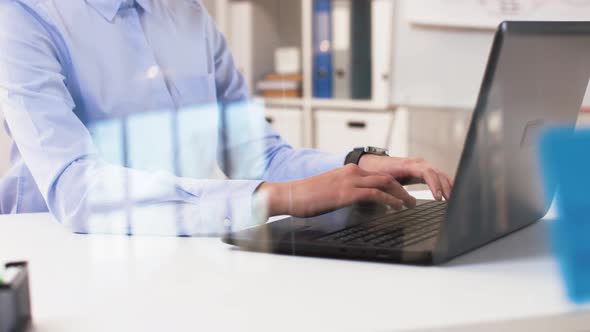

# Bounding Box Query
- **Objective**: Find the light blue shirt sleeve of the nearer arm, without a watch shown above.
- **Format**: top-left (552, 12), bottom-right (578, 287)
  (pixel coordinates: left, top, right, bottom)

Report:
top-left (0, 2), bottom-right (263, 235)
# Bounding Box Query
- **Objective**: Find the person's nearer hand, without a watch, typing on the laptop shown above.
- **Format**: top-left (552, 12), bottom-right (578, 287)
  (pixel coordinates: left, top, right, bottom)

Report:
top-left (258, 165), bottom-right (416, 218)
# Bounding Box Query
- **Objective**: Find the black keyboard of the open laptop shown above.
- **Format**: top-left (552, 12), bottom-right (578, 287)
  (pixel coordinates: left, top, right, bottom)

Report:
top-left (318, 201), bottom-right (447, 248)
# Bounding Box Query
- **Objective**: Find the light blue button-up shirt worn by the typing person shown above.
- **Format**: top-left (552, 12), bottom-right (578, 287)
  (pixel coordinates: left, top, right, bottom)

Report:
top-left (0, 0), bottom-right (343, 235)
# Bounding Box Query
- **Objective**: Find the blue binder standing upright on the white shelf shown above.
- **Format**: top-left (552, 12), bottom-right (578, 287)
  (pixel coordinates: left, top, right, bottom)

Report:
top-left (313, 0), bottom-right (334, 98)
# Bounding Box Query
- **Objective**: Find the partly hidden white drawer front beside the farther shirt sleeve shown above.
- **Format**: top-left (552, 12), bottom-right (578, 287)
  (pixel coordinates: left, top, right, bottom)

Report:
top-left (265, 108), bottom-right (303, 149)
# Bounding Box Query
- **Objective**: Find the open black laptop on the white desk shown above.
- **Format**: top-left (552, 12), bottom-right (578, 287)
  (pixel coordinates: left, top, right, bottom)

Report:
top-left (222, 22), bottom-right (590, 265)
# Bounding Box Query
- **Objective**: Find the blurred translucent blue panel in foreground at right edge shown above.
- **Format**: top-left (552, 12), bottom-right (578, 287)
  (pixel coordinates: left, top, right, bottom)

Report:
top-left (541, 128), bottom-right (590, 303)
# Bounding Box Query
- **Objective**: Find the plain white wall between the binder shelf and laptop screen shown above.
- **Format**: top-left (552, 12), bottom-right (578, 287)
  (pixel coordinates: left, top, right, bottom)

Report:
top-left (392, 0), bottom-right (590, 108)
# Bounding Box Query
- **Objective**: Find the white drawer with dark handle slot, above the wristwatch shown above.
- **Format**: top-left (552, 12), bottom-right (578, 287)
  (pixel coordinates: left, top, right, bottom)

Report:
top-left (314, 110), bottom-right (393, 153)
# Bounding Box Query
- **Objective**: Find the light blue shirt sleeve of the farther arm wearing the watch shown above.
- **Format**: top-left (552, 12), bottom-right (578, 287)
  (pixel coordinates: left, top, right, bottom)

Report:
top-left (208, 9), bottom-right (345, 181)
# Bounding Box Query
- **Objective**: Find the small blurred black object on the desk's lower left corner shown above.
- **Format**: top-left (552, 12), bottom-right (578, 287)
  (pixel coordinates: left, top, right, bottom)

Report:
top-left (0, 262), bottom-right (32, 332)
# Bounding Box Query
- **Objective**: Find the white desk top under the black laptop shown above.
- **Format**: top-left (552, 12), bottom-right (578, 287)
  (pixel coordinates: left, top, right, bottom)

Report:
top-left (0, 192), bottom-right (590, 332)
